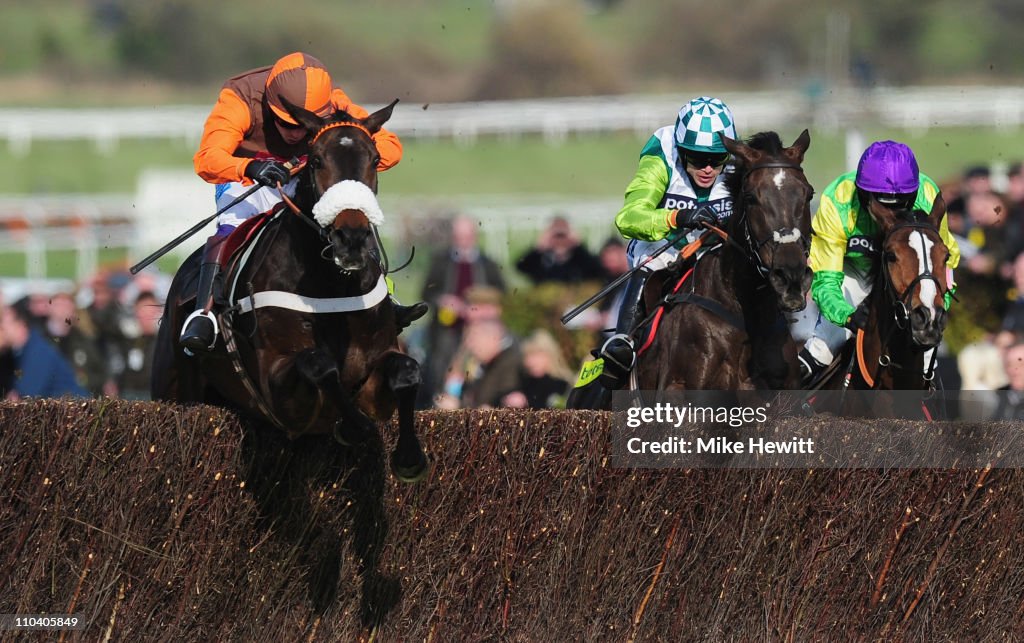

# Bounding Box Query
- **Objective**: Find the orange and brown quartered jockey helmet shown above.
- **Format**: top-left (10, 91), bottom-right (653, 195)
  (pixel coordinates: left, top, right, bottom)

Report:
top-left (266, 51), bottom-right (334, 125)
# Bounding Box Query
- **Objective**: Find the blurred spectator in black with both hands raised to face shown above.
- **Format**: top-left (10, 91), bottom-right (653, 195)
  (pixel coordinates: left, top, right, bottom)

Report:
top-left (516, 216), bottom-right (604, 285)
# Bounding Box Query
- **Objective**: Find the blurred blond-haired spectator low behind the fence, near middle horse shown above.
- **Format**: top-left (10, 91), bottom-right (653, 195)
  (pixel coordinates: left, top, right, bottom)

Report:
top-left (503, 329), bottom-right (572, 409)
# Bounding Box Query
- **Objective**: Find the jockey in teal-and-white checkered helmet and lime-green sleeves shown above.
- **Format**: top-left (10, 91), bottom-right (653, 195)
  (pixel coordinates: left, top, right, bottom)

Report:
top-left (600, 96), bottom-right (737, 389)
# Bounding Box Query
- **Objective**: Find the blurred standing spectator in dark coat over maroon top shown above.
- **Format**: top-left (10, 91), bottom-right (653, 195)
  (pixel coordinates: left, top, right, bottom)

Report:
top-left (418, 216), bottom-right (505, 408)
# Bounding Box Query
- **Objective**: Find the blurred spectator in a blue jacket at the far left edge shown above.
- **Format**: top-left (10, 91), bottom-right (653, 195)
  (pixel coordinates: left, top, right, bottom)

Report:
top-left (0, 306), bottom-right (88, 399)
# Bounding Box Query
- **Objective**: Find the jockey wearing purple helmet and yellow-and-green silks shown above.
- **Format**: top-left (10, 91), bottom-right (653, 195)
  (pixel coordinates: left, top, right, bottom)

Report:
top-left (800, 140), bottom-right (959, 382)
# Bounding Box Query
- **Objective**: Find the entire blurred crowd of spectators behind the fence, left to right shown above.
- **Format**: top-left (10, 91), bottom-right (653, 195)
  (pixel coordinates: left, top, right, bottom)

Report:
top-left (6, 163), bottom-right (1024, 419)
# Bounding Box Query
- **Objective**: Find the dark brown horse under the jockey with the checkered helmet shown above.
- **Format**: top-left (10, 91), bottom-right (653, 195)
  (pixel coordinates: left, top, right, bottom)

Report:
top-left (634, 130), bottom-right (814, 391)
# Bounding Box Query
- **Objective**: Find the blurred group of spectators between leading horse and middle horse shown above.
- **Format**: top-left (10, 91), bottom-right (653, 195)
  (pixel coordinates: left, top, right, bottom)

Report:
top-left (411, 216), bottom-right (629, 409)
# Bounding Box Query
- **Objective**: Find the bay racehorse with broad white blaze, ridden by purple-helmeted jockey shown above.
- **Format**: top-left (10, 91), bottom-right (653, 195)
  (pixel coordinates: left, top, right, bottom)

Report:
top-left (821, 198), bottom-right (949, 390)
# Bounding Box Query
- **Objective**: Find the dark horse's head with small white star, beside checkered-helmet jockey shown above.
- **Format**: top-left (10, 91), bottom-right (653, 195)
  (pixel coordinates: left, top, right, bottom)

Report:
top-left (719, 130), bottom-right (814, 312)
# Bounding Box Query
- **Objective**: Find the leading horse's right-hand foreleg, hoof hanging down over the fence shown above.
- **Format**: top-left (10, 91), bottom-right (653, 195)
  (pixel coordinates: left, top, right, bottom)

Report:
top-left (379, 352), bottom-right (429, 482)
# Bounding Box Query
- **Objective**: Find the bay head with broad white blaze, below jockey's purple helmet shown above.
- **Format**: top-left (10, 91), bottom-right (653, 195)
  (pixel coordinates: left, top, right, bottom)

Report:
top-left (867, 198), bottom-right (949, 348)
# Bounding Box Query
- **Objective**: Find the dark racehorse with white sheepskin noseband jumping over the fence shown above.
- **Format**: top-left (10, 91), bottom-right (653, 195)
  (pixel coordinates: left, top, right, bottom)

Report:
top-left (153, 101), bottom-right (427, 481)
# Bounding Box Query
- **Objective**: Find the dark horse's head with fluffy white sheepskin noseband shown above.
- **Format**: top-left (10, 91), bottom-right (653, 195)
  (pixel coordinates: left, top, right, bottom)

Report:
top-left (282, 98), bottom-right (398, 272)
